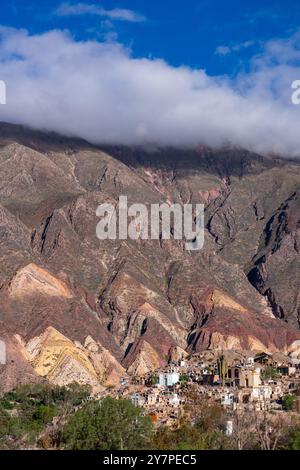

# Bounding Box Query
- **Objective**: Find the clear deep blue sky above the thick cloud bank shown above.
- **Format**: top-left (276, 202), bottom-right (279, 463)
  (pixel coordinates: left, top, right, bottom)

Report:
top-left (0, 0), bottom-right (300, 75)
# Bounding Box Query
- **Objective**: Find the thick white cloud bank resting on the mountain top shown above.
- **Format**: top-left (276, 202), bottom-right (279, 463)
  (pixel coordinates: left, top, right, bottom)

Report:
top-left (0, 27), bottom-right (300, 156)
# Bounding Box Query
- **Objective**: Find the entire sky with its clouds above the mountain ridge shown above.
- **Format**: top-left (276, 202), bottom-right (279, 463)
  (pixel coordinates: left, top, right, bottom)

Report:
top-left (0, 0), bottom-right (300, 157)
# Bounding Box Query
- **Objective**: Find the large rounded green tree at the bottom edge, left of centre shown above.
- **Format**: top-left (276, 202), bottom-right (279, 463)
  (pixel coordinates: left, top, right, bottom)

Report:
top-left (63, 397), bottom-right (152, 450)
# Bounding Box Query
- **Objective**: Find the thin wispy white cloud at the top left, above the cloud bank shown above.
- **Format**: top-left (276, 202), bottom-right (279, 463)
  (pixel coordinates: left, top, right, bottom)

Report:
top-left (56, 2), bottom-right (146, 23)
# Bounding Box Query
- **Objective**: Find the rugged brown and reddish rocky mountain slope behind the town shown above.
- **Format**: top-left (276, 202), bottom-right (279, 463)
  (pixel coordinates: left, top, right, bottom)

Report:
top-left (0, 124), bottom-right (300, 390)
